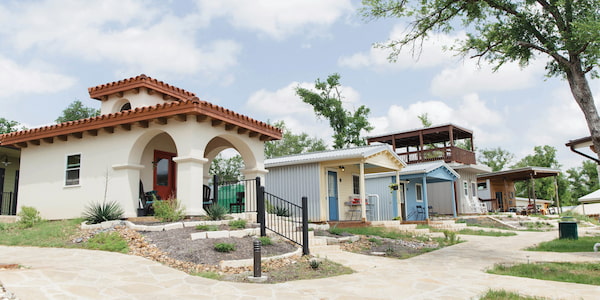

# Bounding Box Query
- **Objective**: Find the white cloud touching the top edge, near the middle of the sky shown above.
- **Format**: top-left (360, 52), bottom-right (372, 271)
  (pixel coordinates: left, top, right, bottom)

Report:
top-left (197, 0), bottom-right (354, 39)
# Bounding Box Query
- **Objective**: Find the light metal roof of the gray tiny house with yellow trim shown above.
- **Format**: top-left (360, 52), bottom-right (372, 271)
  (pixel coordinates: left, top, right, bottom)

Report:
top-left (265, 144), bottom-right (406, 168)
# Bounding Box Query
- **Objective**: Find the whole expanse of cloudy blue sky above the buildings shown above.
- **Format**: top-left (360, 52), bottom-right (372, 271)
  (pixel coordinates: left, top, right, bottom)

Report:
top-left (0, 0), bottom-right (600, 168)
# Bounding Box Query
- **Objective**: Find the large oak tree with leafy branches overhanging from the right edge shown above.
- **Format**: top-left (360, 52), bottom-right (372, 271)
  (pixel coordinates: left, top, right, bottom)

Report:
top-left (362, 0), bottom-right (600, 158)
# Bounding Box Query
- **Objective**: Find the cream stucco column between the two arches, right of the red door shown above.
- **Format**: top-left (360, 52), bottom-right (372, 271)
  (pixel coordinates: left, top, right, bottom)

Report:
top-left (173, 156), bottom-right (208, 216)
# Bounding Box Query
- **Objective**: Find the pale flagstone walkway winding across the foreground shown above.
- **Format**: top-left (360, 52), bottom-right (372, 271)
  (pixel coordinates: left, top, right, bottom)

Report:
top-left (0, 231), bottom-right (600, 300)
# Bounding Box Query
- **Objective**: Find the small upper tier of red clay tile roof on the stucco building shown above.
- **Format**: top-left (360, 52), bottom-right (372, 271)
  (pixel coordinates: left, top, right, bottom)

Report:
top-left (88, 74), bottom-right (196, 100)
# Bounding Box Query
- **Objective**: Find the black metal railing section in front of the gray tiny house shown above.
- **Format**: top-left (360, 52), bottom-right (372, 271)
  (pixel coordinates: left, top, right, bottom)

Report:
top-left (257, 186), bottom-right (310, 255)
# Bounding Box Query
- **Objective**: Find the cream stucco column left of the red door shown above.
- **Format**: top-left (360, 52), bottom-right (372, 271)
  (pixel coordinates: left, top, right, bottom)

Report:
top-left (110, 164), bottom-right (144, 218)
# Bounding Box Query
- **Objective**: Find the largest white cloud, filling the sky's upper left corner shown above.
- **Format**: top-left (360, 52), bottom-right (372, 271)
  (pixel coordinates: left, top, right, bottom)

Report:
top-left (0, 0), bottom-right (241, 75)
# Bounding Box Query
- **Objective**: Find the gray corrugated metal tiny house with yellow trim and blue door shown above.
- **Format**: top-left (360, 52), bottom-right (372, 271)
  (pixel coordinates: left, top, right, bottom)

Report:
top-left (265, 145), bottom-right (405, 221)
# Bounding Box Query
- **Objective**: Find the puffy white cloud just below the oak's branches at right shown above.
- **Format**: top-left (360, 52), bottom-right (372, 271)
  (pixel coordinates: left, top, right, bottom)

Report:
top-left (430, 59), bottom-right (544, 96)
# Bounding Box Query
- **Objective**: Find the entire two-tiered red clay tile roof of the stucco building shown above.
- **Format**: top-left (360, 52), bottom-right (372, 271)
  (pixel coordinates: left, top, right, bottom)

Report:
top-left (0, 75), bottom-right (281, 147)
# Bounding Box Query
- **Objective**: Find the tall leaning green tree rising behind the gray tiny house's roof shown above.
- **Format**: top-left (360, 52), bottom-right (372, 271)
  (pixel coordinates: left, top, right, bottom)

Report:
top-left (296, 74), bottom-right (373, 149)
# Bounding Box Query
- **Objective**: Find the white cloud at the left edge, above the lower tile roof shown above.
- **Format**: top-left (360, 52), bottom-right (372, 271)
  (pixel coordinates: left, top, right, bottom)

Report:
top-left (0, 56), bottom-right (75, 102)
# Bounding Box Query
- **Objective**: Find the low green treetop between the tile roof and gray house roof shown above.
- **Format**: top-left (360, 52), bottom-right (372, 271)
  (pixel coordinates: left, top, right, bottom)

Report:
top-left (265, 121), bottom-right (327, 158)
